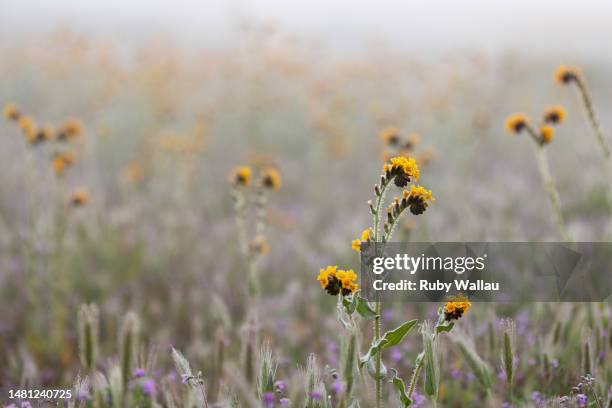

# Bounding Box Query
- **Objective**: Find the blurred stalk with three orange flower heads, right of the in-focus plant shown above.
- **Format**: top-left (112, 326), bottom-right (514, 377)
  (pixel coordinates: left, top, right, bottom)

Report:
top-left (506, 110), bottom-right (572, 241)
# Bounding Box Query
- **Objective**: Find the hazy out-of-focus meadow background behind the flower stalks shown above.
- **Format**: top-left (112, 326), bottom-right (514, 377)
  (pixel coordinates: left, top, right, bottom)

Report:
top-left (0, 2), bottom-right (612, 407)
